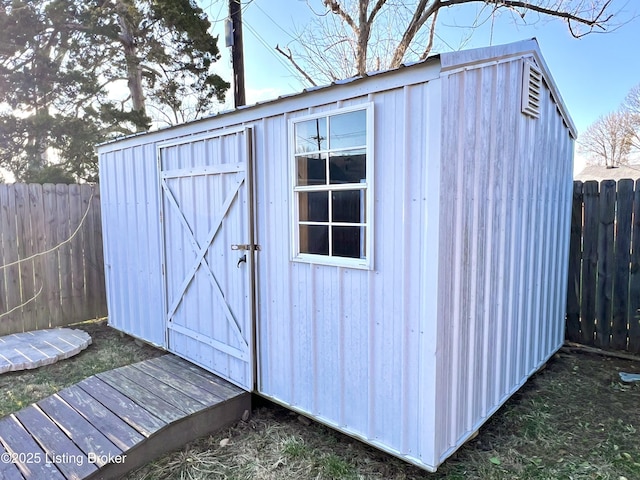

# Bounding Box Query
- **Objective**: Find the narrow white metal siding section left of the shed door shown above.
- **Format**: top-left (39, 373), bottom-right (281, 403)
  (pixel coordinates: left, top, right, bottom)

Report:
top-left (100, 145), bottom-right (165, 346)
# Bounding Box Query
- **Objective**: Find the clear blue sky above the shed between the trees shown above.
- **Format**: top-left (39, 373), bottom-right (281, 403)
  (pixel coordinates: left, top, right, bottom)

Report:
top-left (199, 0), bottom-right (640, 171)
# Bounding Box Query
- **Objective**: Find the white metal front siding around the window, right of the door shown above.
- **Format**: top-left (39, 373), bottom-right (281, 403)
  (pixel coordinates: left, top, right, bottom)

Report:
top-left (256, 80), bottom-right (440, 463)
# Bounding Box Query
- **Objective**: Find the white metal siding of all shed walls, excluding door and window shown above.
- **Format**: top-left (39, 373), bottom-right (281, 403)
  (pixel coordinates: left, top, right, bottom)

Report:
top-left (100, 42), bottom-right (573, 469)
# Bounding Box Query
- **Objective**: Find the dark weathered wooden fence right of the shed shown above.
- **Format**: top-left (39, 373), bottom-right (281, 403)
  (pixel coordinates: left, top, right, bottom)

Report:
top-left (566, 180), bottom-right (640, 353)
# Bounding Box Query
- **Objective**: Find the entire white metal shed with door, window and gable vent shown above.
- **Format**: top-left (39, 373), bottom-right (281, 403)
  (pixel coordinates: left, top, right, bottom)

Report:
top-left (98, 40), bottom-right (576, 471)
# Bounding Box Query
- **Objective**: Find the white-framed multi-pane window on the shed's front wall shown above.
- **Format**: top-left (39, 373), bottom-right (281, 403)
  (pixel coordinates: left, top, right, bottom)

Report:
top-left (290, 104), bottom-right (373, 268)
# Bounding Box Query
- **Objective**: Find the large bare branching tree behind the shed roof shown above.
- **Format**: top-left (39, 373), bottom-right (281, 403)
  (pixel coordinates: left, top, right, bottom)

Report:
top-left (280, 0), bottom-right (617, 82)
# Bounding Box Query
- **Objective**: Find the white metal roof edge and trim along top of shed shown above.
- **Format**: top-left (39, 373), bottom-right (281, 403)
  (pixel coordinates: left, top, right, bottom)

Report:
top-left (100, 38), bottom-right (577, 146)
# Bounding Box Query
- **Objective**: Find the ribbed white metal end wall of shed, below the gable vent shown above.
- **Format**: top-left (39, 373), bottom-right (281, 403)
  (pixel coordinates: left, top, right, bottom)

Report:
top-left (436, 59), bottom-right (573, 461)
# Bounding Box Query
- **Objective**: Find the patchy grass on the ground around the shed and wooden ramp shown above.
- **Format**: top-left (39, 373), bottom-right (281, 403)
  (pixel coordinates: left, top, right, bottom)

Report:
top-left (0, 323), bottom-right (640, 480)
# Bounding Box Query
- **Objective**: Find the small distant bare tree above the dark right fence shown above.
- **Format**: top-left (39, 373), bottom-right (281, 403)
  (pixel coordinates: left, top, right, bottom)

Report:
top-left (578, 110), bottom-right (634, 168)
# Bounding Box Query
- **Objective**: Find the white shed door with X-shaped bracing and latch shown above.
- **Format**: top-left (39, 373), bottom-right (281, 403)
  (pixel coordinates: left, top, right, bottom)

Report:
top-left (159, 129), bottom-right (255, 390)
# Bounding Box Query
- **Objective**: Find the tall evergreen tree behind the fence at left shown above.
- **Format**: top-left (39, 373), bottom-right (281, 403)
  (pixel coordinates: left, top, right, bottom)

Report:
top-left (0, 0), bottom-right (229, 180)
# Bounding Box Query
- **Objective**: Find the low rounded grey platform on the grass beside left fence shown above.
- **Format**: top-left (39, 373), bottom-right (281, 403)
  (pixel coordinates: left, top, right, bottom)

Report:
top-left (0, 328), bottom-right (91, 374)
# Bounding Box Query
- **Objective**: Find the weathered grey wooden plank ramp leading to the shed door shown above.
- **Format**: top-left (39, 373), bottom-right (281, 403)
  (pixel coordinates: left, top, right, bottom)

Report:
top-left (0, 355), bottom-right (251, 480)
